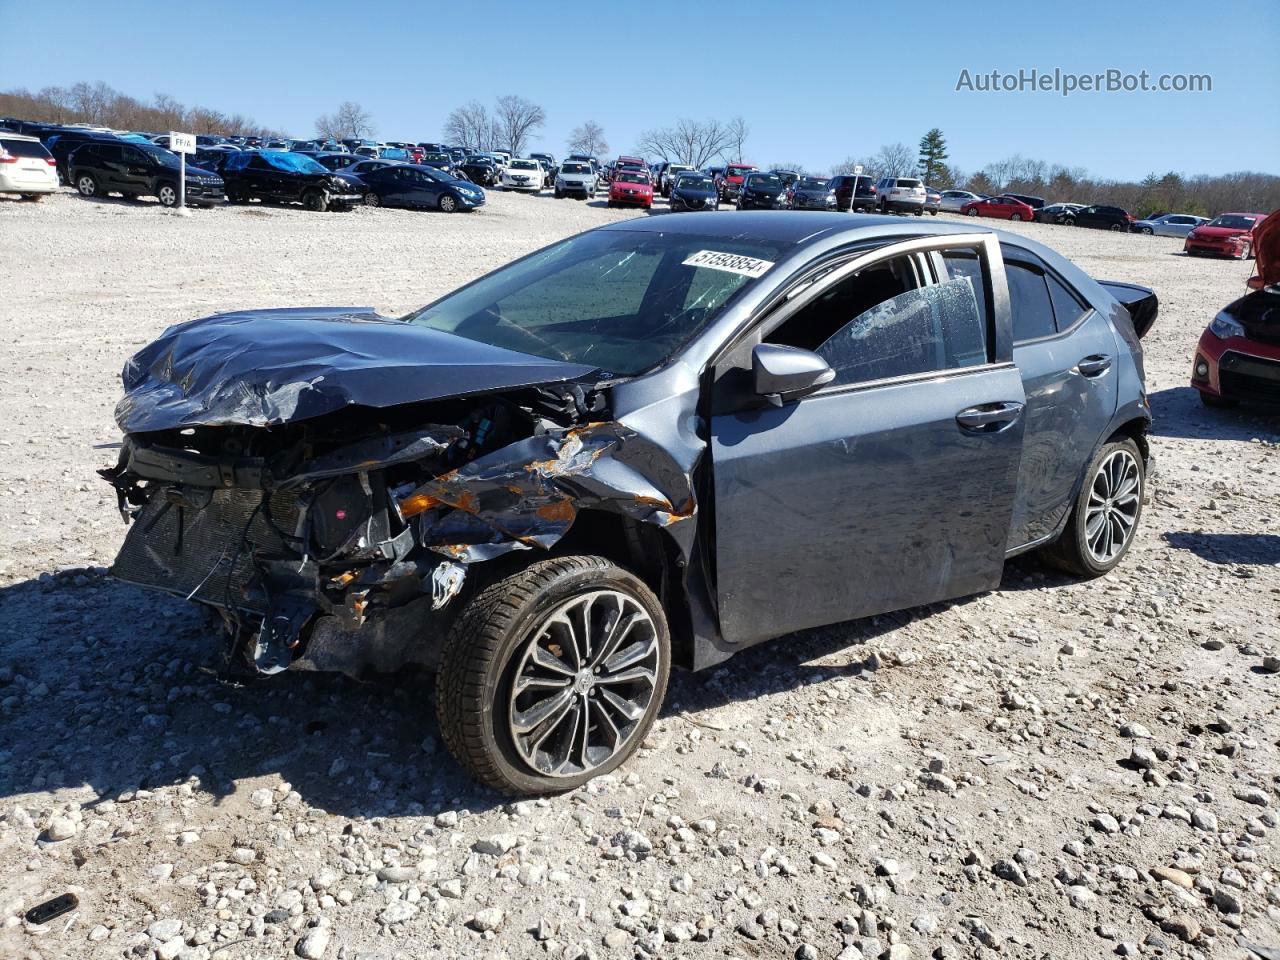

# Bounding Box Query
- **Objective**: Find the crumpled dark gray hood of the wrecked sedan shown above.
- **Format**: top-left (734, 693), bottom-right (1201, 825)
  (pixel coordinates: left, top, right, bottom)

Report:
top-left (115, 307), bottom-right (596, 433)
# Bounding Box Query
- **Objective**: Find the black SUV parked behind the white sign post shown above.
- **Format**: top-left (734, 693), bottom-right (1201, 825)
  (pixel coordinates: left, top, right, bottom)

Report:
top-left (67, 141), bottom-right (225, 206)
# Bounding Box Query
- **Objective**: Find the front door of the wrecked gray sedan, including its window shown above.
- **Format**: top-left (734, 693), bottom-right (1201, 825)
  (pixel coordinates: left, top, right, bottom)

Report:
top-left (710, 234), bottom-right (1024, 644)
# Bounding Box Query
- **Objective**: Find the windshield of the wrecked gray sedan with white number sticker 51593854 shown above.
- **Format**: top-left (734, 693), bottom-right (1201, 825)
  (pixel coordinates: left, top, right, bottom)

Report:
top-left (404, 230), bottom-right (782, 375)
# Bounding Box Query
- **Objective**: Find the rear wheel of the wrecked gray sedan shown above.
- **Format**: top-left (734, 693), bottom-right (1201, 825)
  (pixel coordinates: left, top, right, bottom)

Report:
top-left (1043, 442), bottom-right (1146, 579)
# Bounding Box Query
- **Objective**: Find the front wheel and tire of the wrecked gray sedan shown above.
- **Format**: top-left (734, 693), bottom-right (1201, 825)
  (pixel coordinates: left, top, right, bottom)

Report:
top-left (436, 557), bottom-right (671, 794)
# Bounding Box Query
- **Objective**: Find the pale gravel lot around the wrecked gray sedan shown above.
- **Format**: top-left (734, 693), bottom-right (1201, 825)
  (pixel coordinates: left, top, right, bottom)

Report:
top-left (0, 193), bottom-right (1280, 960)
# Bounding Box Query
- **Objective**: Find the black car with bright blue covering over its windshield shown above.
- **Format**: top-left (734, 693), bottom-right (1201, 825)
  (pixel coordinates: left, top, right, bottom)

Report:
top-left (223, 150), bottom-right (369, 212)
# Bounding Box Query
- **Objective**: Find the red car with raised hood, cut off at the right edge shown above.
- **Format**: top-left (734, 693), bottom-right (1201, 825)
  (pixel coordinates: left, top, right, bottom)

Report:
top-left (1192, 214), bottom-right (1280, 407)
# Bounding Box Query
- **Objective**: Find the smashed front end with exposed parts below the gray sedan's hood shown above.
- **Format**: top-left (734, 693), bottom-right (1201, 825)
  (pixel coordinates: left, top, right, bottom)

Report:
top-left (101, 387), bottom-right (694, 675)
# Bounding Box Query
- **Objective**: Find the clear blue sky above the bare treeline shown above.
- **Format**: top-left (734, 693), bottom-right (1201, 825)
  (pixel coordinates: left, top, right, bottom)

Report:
top-left (0, 0), bottom-right (1280, 179)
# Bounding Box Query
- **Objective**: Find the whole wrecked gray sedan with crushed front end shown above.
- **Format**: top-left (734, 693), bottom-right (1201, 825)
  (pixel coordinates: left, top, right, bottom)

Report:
top-left (102, 212), bottom-right (1156, 794)
